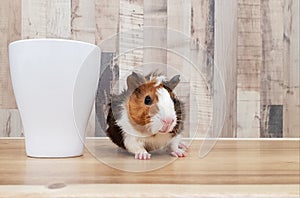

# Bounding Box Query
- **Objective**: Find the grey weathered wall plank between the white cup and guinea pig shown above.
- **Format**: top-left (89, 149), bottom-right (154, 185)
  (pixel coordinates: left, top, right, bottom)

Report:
top-left (95, 52), bottom-right (119, 137)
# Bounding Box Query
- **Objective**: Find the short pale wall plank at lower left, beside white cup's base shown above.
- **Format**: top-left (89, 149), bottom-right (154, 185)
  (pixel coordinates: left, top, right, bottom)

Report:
top-left (0, 109), bottom-right (24, 137)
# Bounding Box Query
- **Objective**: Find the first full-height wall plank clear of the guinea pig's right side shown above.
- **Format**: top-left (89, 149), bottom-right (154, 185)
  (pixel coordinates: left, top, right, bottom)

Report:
top-left (189, 0), bottom-right (215, 137)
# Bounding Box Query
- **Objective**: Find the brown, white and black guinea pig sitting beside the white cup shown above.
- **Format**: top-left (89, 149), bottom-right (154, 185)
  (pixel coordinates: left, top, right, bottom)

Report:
top-left (106, 72), bottom-right (187, 160)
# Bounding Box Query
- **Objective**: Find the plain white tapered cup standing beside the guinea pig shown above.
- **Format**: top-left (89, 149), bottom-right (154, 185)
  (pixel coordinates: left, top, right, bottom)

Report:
top-left (9, 39), bottom-right (101, 157)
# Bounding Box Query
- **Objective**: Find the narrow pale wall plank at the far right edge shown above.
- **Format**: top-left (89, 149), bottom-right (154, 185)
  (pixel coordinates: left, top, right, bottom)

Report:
top-left (283, 0), bottom-right (300, 138)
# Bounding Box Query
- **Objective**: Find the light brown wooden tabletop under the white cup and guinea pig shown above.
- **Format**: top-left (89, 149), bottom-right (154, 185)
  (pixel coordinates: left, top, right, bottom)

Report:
top-left (0, 139), bottom-right (300, 197)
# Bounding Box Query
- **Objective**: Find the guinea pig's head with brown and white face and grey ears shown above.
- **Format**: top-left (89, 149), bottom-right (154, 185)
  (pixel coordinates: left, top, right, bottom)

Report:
top-left (127, 72), bottom-right (180, 134)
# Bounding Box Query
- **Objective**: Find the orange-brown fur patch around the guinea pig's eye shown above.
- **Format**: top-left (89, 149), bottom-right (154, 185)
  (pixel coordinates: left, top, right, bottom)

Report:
top-left (127, 81), bottom-right (162, 126)
